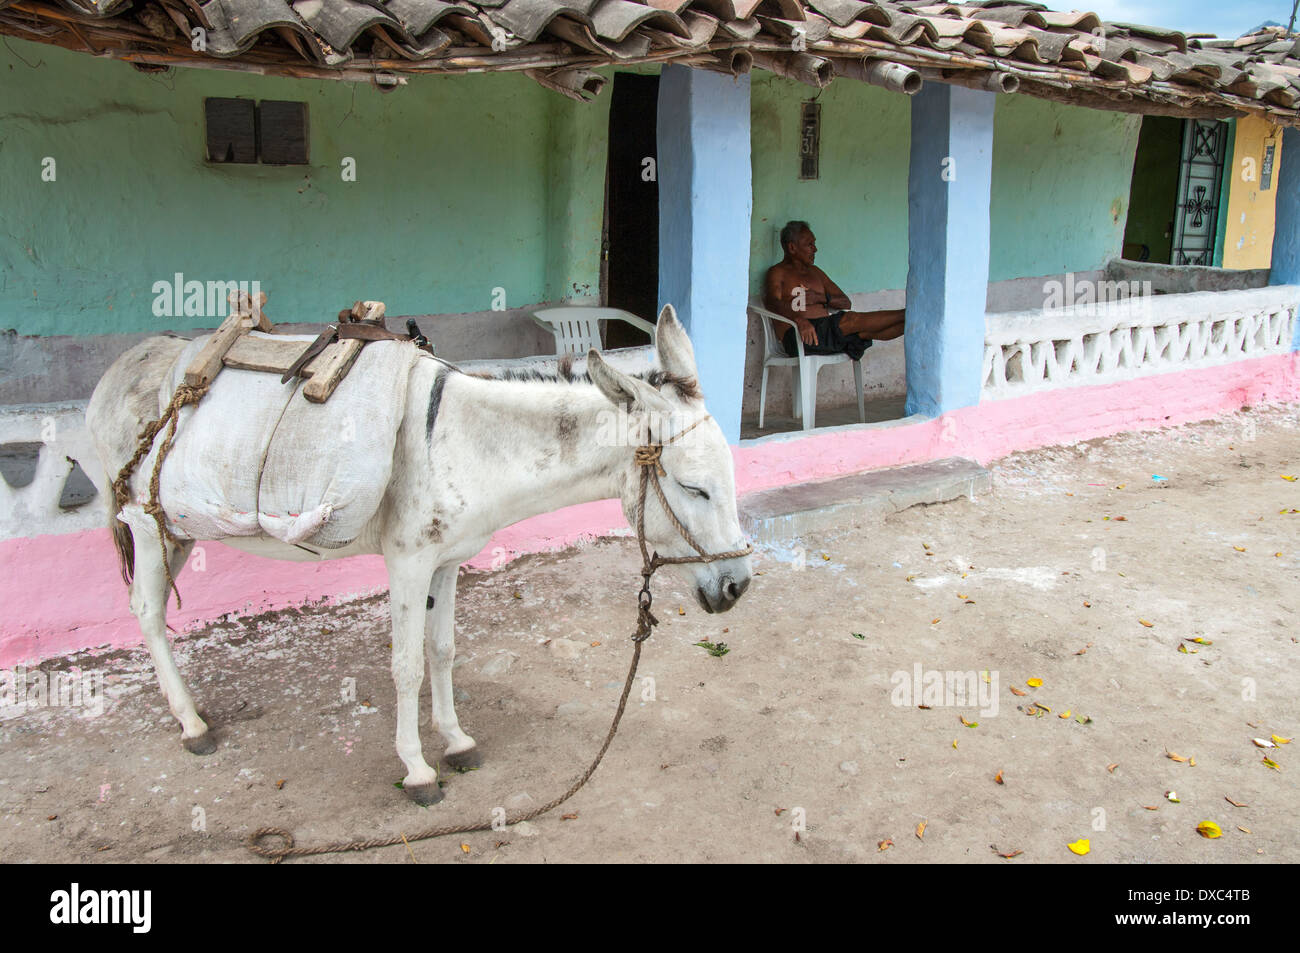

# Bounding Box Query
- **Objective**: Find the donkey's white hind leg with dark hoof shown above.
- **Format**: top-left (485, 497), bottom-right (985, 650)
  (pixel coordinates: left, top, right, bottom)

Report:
top-left (131, 524), bottom-right (217, 754)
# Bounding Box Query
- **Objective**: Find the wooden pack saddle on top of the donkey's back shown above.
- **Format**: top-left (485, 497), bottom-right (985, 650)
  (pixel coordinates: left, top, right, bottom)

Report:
top-left (185, 291), bottom-right (433, 403)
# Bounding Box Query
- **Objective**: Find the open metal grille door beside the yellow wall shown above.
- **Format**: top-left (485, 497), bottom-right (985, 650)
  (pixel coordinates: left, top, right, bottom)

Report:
top-left (1171, 120), bottom-right (1229, 265)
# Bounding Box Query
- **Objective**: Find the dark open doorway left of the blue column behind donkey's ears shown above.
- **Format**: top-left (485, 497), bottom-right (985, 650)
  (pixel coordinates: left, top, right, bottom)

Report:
top-left (601, 73), bottom-right (659, 347)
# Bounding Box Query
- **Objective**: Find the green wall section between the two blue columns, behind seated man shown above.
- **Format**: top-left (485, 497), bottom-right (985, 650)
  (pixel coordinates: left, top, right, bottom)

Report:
top-left (749, 70), bottom-right (911, 294)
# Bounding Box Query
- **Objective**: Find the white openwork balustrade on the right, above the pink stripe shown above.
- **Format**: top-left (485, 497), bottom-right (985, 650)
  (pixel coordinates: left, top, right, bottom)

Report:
top-left (983, 285), bottom-right (1300, 400)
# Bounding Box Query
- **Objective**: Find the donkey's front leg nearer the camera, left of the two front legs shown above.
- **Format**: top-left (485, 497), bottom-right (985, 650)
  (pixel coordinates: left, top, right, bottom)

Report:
top-left (387, 554), bottom-right (442, 806)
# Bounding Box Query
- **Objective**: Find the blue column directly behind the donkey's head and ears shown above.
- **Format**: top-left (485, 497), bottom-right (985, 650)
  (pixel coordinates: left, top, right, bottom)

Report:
top-left (658, 65), bottom-right (753, 443)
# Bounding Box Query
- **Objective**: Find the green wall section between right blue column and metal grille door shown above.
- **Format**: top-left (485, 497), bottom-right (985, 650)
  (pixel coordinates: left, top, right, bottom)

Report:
top-left (987, 95), bottom-right (1141, 281)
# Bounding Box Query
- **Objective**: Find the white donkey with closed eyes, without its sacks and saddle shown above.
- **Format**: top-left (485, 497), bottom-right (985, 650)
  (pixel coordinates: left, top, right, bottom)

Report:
top-left (86, 306), bottom-right (750, 805)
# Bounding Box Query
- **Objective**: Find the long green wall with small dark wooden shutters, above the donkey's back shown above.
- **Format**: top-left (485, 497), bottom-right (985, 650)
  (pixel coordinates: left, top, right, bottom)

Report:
top-left (0, 39), bottom-right (607, 334)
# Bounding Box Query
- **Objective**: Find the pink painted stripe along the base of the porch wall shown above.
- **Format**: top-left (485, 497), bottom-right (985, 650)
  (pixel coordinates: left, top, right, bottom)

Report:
top-left (0, 345), bottom-right (1300, 667)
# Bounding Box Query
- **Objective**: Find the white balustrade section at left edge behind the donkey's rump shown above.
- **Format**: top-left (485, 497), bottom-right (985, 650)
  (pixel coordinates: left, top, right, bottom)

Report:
top-left (0, 403), bottom-right (108, 540)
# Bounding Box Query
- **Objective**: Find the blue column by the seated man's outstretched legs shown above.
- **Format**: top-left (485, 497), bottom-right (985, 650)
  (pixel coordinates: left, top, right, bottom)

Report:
top-left (904, 83), bottom-right (996, 416)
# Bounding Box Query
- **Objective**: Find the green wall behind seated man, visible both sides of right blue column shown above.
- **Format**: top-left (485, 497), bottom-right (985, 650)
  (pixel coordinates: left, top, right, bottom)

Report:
top-left (750, 72), bottom-right (1140, 293)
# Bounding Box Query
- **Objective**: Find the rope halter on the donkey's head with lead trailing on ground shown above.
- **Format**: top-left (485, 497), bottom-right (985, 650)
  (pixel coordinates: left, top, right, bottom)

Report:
top-left (244, 415), bottom-right (754, 863)
